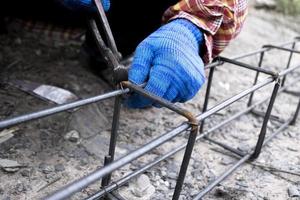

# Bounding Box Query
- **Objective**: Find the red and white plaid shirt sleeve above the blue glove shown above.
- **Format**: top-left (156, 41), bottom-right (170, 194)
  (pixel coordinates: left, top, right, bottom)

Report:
top-left (163, 0), bottom-right (248, 63)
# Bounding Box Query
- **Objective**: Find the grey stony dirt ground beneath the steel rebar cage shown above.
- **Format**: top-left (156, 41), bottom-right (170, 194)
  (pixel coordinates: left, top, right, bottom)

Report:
top-left (0, 7), bottom-right (300, 200)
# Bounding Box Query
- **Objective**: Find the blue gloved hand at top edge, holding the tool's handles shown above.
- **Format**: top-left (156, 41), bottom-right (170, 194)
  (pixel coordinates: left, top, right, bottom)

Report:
top-left (59, 0), bottom-right (110, 11)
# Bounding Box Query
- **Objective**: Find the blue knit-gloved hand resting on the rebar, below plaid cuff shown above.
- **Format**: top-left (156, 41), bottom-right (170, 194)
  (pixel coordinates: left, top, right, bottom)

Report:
top-left (126, 19), bottom-right (205, 108)
